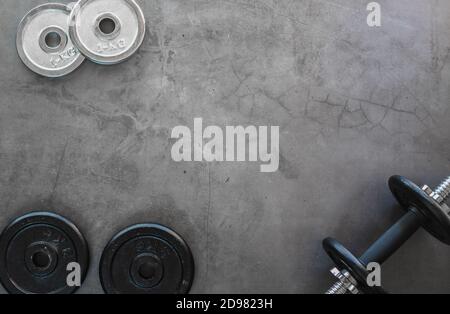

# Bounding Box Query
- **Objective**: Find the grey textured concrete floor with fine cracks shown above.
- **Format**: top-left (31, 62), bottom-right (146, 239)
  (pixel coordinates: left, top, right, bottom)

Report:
top-left (0, 0), bottom-right (450, 293)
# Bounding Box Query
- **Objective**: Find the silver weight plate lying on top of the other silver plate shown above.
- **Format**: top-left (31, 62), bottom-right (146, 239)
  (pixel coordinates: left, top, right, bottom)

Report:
top-left (69, 0), bottom-right (145, 65)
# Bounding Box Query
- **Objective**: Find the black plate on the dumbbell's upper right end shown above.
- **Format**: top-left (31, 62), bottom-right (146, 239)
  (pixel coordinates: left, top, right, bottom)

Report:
top-left (389, 176), bottom-right (450, 245)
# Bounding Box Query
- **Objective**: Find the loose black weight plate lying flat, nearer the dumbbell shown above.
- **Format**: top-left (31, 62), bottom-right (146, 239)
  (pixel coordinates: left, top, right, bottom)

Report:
top-left (100, 224), bottom-right (194, 294)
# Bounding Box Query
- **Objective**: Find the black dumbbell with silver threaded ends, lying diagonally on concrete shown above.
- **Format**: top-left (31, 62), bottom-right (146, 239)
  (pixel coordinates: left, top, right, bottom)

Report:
top-left (323, 176), bottom-right (450, 294)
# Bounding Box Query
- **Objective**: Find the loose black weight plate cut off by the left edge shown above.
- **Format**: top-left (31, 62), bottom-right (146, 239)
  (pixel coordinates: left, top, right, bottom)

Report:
top-left (0, 212), bottom-right (89, 294)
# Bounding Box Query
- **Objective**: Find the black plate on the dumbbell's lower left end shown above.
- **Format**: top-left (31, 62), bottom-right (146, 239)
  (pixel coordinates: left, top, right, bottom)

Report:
top-left (322, 238), bottom-right (386, 294)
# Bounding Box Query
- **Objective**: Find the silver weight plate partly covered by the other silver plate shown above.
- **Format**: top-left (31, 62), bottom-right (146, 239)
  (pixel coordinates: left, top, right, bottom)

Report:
top-left (16, 3), bottom-right (85, 77)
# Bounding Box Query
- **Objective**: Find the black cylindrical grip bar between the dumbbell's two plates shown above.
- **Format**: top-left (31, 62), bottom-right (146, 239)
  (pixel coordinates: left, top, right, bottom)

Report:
top-left (360, 209), bottom-right (423, 265)
